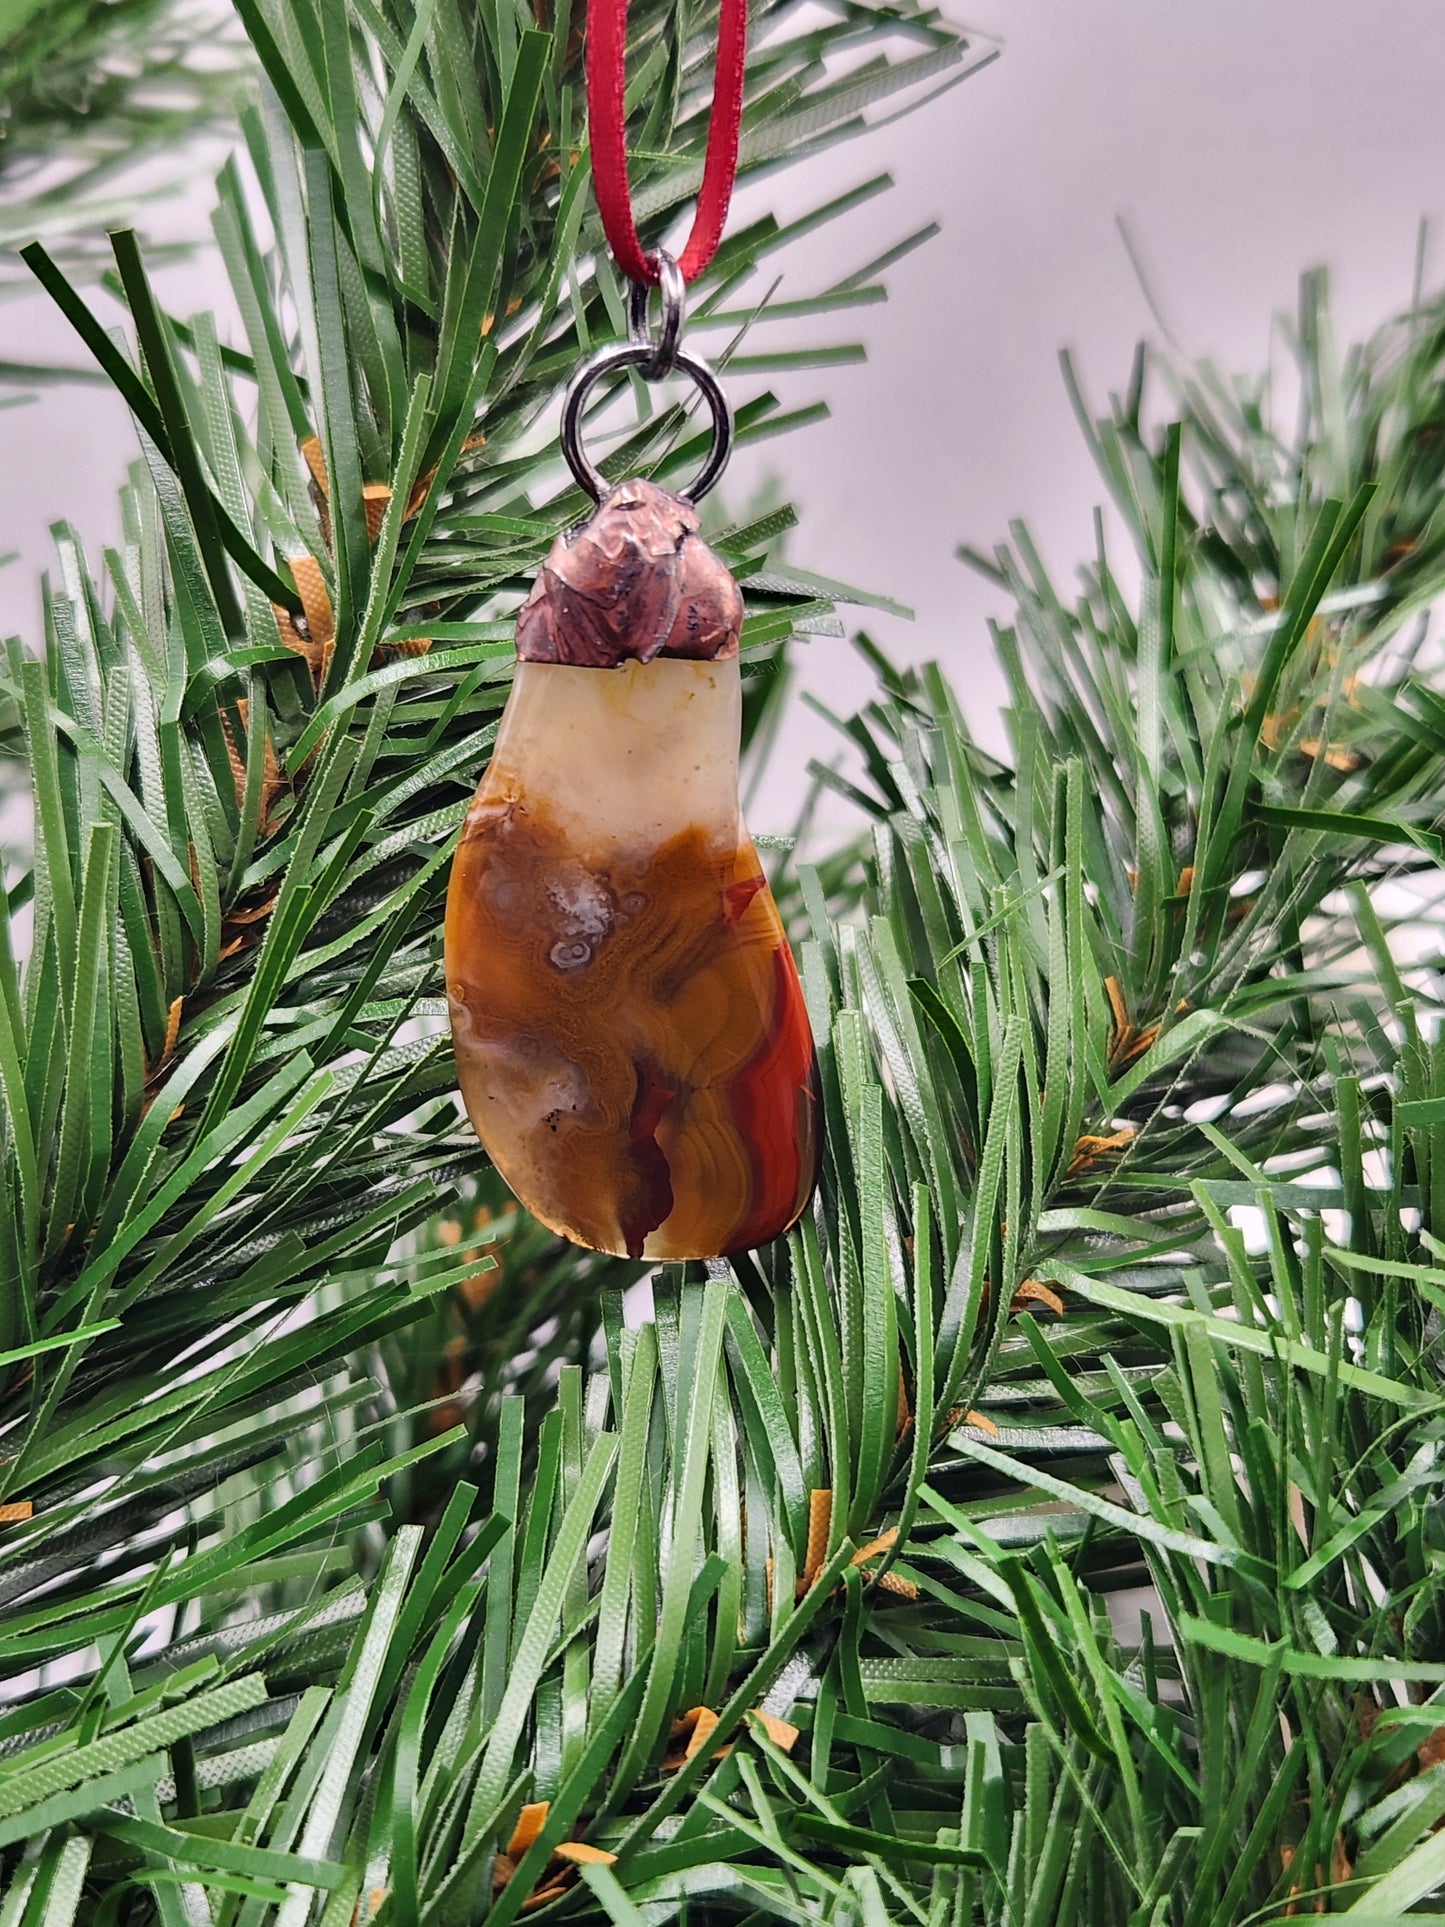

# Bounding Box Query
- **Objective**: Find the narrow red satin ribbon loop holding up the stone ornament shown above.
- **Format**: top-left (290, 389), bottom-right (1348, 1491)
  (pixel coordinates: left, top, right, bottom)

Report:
top-left (588, 0), bottom-right (748, 287)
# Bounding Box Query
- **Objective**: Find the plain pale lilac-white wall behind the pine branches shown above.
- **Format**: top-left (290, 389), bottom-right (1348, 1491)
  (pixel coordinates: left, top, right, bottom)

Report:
top-left (0, 0), bottom-right (1445, 829)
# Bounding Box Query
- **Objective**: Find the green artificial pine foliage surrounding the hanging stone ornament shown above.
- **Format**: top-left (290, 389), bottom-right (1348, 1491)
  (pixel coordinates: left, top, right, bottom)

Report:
top-left (0, 0), bottom-right (1445, 1927)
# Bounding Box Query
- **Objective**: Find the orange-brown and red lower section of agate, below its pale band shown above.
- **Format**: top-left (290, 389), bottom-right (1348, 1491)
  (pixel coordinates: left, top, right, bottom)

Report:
top-left (447, 797), bottom-right (819, 1258)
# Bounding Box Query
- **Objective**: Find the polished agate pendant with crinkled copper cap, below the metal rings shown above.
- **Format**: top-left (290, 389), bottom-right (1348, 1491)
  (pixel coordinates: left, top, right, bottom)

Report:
top-left (445, 484), bottom-right (819, 1258)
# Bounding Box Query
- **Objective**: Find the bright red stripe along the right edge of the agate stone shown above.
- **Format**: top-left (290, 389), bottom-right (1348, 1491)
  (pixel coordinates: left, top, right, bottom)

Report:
top-left (728, 944), bottom-right (817, 1251)
